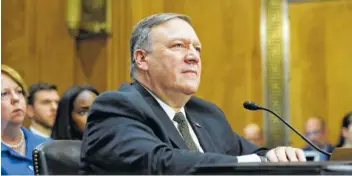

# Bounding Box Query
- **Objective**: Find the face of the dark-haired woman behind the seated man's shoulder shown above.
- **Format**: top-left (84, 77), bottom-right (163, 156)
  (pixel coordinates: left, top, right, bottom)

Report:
top-left (72, 90), bottom-right (97, 132)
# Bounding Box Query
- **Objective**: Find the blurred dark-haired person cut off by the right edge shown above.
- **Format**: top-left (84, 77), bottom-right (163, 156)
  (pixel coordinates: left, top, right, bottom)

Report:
top-left (336, 112), bottom-right (352, 148)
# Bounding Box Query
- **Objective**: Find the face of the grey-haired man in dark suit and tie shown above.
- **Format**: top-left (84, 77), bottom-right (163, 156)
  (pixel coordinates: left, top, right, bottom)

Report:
top-left (145, 19), bottom-right (201, 95)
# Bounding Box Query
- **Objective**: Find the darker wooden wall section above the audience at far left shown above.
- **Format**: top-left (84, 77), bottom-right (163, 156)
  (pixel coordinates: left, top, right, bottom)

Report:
top-left (1, 0), bottom-right (107, 93)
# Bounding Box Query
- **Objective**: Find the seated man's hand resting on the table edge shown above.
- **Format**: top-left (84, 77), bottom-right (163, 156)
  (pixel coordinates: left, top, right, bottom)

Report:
top-left (266, 147), bottom-right (306, 162)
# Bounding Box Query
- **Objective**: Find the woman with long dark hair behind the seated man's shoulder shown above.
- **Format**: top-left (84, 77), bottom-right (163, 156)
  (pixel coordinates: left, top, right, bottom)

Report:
top-left (51, 85), bottom-right (99, 140)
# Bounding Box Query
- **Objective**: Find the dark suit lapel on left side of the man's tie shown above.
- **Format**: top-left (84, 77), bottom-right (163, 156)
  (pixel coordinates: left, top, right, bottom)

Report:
top-left (132, 82), bottom-right (188, 149)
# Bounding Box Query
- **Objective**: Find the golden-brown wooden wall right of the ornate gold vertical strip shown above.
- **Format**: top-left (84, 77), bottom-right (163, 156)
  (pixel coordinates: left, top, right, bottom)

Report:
top-left (289, 0), bottom-right (352, 146)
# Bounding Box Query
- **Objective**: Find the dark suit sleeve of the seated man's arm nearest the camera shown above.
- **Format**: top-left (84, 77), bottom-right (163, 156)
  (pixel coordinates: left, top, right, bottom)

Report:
top-left (81, 92), bottom-right (237, 174)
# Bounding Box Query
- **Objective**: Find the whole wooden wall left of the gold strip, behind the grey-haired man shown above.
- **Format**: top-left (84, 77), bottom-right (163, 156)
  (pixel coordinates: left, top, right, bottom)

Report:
top-left (2, 0), bottom-right (262, 133)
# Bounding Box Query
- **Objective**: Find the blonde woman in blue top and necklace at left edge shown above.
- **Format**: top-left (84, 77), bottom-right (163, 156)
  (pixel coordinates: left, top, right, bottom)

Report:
top-left (1, 65), bottom-right (49, 175)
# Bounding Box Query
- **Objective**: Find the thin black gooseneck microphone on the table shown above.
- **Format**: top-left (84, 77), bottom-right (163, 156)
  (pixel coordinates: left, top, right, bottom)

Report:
top-left (243, 101), bottom-right (331, 157)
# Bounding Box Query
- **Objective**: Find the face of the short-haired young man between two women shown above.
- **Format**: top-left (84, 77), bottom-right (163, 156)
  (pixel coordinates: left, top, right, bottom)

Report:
top-left (31, 90), bottom-right (60, 128)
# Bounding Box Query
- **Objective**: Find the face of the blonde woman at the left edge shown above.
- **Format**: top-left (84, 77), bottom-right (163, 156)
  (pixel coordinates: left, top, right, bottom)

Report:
top-left (1, 72), bottom-right (26, 130)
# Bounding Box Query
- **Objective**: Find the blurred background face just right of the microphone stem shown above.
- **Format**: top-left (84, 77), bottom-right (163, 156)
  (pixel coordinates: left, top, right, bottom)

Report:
top-left (306, 119), bottom-right (325, 146)
